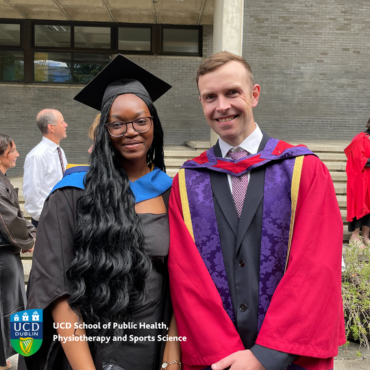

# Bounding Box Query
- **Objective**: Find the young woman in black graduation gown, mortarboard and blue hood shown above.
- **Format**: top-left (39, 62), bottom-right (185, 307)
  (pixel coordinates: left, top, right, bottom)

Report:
top-left (20, 55), bottom-right (180, 370)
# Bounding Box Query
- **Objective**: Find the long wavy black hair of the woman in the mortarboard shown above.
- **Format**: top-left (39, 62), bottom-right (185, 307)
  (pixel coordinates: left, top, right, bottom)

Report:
top-left (67, 94), bottom-right (165, 348)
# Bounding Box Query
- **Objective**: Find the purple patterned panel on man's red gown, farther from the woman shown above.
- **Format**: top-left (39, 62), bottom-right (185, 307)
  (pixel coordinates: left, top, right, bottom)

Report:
top-left (258, 158), bottom-right (295, 331)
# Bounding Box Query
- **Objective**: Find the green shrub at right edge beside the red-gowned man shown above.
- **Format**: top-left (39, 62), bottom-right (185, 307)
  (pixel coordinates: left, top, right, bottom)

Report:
top-left (342, 242), bottom-right (370, 348)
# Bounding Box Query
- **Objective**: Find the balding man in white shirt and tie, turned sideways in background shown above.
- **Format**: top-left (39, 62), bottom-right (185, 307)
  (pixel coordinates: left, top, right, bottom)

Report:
top-left (23, 109), bottom-right (68, 227)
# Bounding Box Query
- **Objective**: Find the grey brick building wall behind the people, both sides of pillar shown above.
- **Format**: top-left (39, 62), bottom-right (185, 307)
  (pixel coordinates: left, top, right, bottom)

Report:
top-left (0, 0), bottom-right (370, 176)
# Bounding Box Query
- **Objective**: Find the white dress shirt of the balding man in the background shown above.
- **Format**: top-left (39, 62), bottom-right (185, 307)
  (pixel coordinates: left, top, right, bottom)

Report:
top-left (23, 137), bottom-right (67, 221)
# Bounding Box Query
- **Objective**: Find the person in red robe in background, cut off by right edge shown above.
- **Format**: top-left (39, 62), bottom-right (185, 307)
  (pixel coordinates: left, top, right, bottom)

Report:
top-left (344, 118), bottom-right (370, 248)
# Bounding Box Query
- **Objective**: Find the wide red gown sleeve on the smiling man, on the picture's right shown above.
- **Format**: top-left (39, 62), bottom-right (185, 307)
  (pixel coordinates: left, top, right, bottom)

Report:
top-left (256, 156), bottom-right (346, 358)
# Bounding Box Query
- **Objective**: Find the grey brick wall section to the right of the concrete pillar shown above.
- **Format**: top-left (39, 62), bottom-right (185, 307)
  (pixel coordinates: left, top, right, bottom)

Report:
top-left (243, 0), bottom-right (370, 140)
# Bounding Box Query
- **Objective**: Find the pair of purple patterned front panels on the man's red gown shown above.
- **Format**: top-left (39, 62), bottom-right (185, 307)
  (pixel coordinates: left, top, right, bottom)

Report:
top-left (185, 158), bottom-right (295, 330)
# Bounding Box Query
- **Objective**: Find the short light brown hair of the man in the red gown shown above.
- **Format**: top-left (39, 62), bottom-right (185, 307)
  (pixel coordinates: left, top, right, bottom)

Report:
top-left (197, 51), bottom-right (254, 87)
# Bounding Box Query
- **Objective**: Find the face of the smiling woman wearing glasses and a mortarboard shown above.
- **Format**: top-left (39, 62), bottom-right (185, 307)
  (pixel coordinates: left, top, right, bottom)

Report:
top-left (108, 94), bottom-right (154, 162)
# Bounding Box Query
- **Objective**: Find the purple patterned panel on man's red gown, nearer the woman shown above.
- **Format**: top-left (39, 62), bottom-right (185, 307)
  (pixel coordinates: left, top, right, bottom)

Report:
top-left (185, 170), bottom-right (235, 323)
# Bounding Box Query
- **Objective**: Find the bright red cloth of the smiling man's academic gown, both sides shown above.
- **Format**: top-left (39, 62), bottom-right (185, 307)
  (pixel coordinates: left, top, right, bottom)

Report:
top-left (168, 156), bottom-right (346, 370)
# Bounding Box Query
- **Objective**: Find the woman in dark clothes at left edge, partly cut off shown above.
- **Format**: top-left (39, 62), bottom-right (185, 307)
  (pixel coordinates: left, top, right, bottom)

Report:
top-left (0, 134), bottom-right (36, 370)
